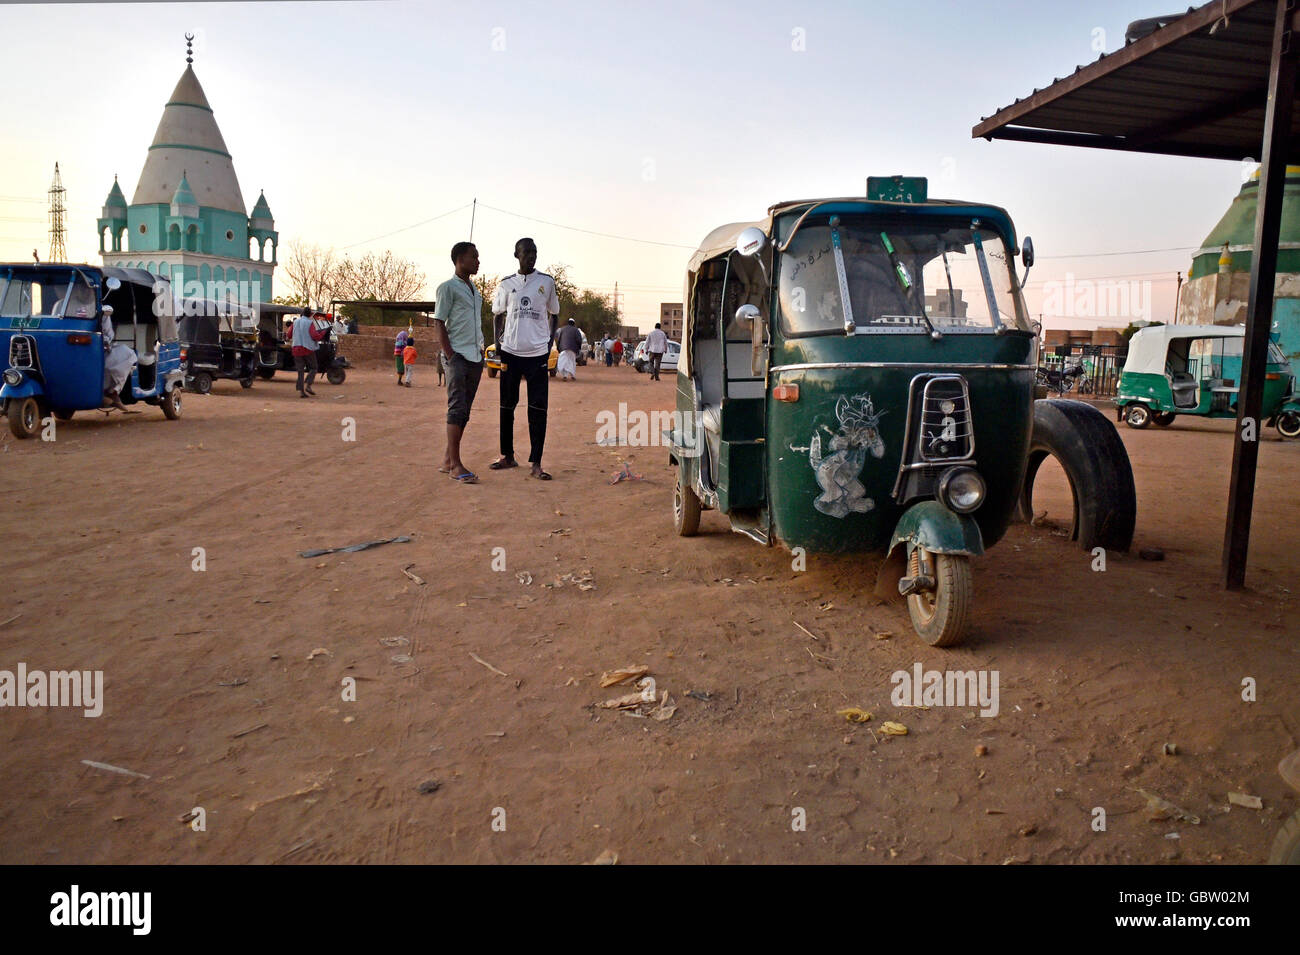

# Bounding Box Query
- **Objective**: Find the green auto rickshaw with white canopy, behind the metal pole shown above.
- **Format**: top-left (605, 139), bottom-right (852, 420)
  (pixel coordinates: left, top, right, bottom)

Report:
top-left (1115, 325), bottom-right (1300, 438)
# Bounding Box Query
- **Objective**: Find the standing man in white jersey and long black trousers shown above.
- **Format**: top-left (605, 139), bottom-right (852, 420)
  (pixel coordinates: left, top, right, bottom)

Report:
top-left (489, 239), bottom-right (560, 481)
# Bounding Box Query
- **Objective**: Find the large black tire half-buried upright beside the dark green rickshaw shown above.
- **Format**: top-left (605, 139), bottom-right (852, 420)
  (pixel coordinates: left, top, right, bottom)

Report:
top-left (1019, 398), bottom-right (1138, 551)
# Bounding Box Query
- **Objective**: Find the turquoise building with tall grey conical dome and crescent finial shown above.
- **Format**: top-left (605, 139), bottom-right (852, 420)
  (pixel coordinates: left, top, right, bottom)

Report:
top-left (98, 38), bottom-right (280, 304)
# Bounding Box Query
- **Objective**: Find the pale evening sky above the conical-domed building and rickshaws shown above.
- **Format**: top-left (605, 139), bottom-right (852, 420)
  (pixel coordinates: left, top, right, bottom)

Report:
top-left (0, 0), bottom-right (1258, 331)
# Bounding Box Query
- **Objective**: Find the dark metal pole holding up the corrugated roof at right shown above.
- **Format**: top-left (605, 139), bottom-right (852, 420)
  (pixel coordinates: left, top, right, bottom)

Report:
top-left (1222, 0), bottom-right (1297, 590)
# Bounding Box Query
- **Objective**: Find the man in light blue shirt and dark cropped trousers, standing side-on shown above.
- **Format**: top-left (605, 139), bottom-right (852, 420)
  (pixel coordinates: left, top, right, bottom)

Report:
top-left (433, 242), bottom-right (484, 485)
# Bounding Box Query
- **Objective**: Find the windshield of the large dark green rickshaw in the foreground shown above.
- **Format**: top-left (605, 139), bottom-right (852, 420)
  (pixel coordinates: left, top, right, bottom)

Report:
top-left (777, 216), bottom-right (1030, 335)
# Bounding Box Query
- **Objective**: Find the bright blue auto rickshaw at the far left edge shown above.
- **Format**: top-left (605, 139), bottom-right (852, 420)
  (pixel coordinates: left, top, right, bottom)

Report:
top-left (0, 264), bottom-right (183, 438)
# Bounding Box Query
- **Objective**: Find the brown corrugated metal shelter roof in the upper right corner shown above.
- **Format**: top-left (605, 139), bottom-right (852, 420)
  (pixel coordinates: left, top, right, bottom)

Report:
top-left (971, 0), bottom-right (1300, 160)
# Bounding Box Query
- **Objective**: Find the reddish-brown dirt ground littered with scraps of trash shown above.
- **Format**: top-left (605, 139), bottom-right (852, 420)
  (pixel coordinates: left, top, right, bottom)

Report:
top-left (0, 366), bottom-right (1300, 863)
